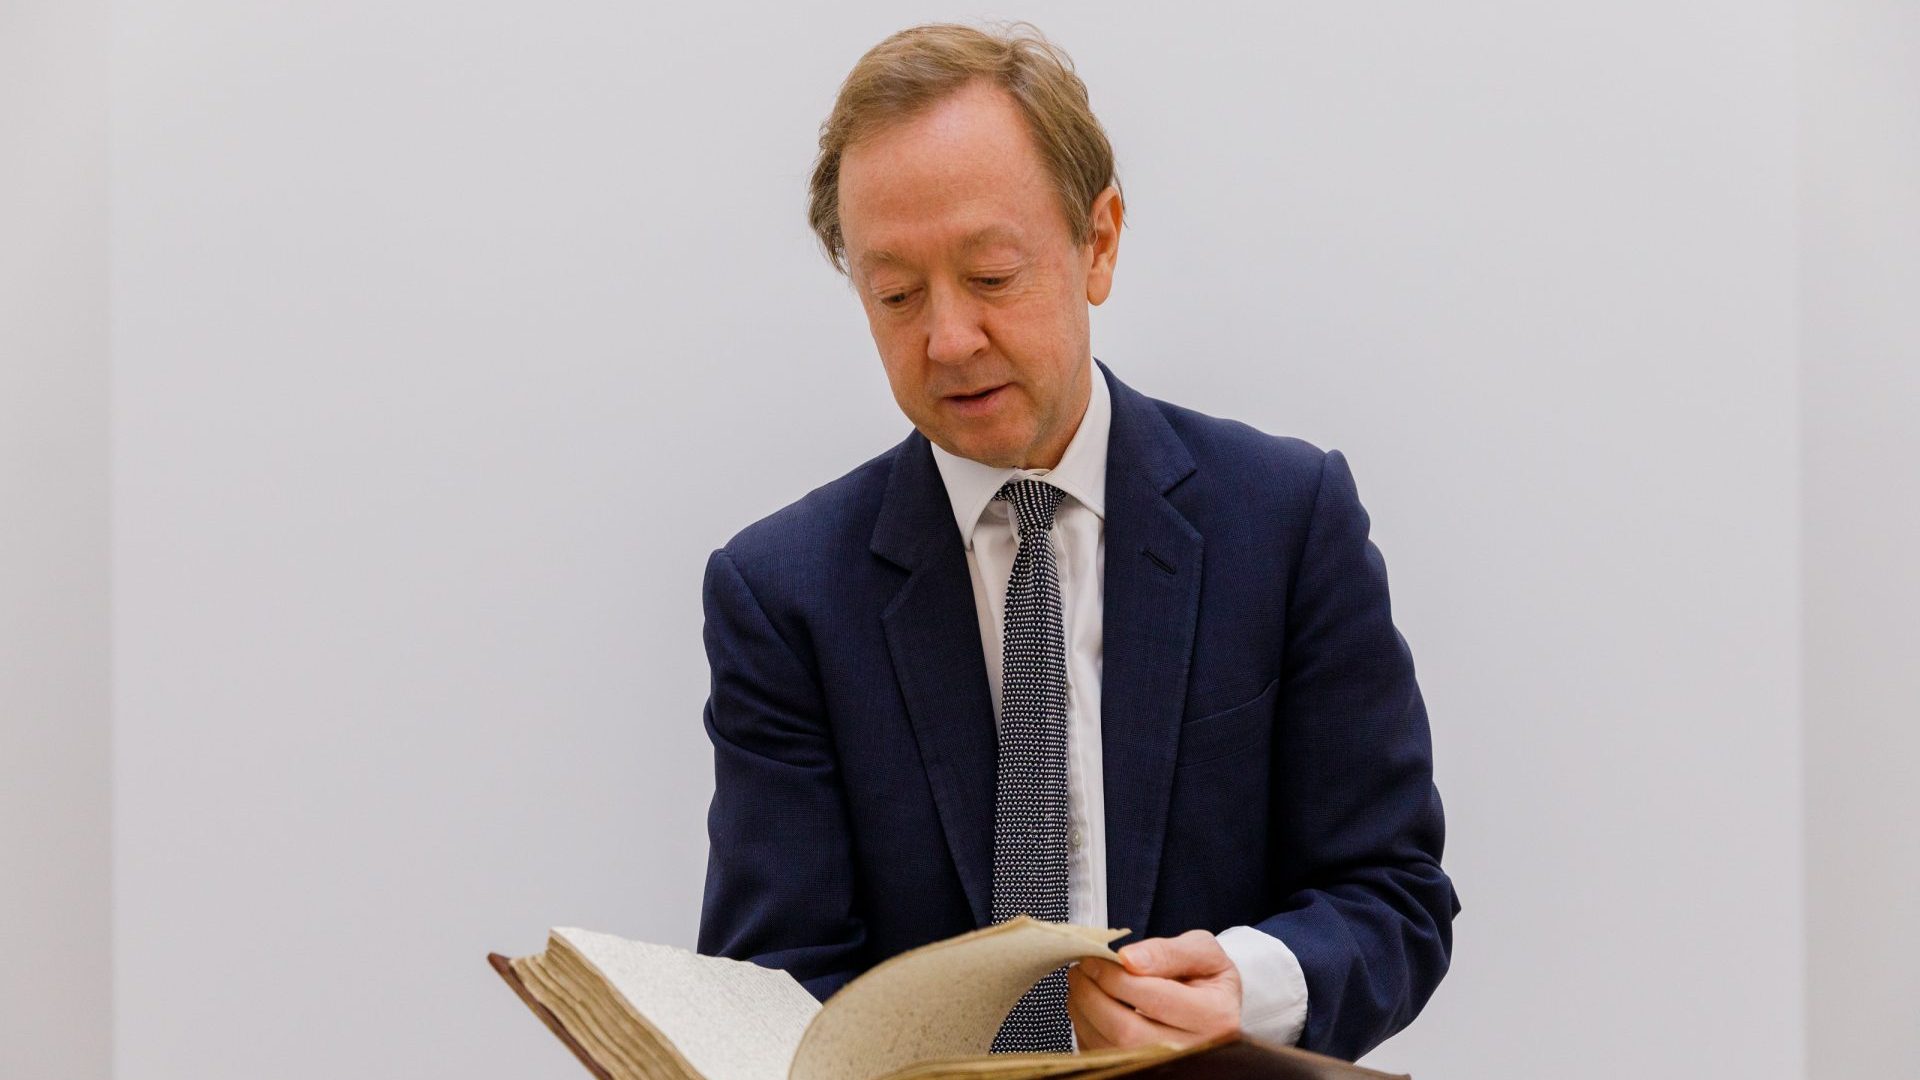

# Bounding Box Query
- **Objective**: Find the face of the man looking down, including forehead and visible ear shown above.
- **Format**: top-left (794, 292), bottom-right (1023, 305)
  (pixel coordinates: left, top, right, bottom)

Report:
top-left (839, 81), bottom-right (1121, 469)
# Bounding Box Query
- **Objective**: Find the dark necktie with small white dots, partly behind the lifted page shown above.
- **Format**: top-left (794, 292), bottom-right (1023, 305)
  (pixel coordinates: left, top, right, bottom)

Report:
top-left (993, 480), bottom-right (1073, 1053)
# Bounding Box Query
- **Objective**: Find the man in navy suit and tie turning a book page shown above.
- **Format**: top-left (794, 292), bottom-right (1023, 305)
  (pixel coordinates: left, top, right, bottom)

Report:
top-left (699, 25), bottom-right (1459, 1059)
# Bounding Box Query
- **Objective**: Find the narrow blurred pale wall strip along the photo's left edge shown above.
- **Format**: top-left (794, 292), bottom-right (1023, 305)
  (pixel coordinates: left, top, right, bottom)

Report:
top-left (0, 0), bottom-right (111, 1080)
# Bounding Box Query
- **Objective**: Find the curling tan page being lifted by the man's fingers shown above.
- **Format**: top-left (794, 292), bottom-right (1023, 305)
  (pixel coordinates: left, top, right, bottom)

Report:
top-left (791, 915), bottom-right (1127, 1080)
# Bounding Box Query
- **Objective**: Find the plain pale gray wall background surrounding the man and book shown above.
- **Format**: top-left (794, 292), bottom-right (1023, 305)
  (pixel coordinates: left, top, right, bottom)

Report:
top-left (0, 0), bottom-right (1920, 1080)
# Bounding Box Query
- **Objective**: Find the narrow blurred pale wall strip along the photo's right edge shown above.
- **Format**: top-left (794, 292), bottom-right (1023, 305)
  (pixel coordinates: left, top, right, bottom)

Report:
top-left (1799, 0), bottom-right (1920, 1080)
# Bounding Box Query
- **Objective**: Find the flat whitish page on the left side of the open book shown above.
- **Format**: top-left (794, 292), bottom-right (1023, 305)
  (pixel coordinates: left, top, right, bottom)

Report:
top-left (549, 926), bottom-right (820, 1080)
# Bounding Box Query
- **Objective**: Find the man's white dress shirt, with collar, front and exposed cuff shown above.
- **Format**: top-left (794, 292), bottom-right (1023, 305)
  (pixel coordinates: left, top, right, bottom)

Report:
top-left (933, 356), bottom-right (1308, 1045)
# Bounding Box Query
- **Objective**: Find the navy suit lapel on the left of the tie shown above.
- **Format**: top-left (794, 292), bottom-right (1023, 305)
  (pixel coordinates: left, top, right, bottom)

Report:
top-left (872, 432), bottom-right (998, 926)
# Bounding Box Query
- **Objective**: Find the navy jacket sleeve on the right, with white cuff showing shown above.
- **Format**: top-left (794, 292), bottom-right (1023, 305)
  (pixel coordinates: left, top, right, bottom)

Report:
top-left (1256, 450), bottom-right (1459, 1061)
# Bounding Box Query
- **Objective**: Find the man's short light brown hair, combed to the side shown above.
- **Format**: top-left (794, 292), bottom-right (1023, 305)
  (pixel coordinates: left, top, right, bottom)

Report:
top-left (806, 23), bottom-right (1119, 273)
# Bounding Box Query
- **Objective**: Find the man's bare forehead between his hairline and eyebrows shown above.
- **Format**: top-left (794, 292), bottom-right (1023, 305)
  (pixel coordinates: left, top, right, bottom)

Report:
top-left (839, 83), bottom-right (1068, 269)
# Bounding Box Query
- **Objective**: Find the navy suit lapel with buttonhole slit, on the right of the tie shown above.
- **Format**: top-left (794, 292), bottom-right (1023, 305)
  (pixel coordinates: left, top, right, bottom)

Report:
top-left (1100, 363), bottom-right (1202, 938)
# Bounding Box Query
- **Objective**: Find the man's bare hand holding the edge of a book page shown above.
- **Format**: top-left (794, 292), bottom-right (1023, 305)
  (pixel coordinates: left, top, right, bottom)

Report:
top-left (1068, 930), bottom-right (1240, 1049)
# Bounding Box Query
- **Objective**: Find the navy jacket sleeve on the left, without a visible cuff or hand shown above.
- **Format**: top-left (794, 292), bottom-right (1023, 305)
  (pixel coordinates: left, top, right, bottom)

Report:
top-left (699, 548), bottom-right (866, 1001)
